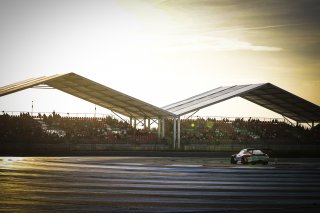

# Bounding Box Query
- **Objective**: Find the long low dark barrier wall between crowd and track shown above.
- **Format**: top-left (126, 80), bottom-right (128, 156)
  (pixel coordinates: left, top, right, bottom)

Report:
top-left (0, 143), bottom-right (320, 156)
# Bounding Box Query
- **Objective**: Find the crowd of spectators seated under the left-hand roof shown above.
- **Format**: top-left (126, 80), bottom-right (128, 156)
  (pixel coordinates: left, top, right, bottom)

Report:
top-left (0, 112), bottom-right (158, 143)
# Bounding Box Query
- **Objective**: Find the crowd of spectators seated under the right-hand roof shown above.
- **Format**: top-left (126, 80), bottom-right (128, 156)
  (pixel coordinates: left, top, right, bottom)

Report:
top-left (167, 118), bottom-right (320, 144)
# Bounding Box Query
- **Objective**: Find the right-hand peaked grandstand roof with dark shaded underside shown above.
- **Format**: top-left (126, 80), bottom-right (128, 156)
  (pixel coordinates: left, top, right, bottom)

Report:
top-left (163, 83), bottom-right (320, 123)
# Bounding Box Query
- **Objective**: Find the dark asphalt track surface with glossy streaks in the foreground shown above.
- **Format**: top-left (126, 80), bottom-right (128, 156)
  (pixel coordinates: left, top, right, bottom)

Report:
top-left (0, 156), bottom-right (320, 212)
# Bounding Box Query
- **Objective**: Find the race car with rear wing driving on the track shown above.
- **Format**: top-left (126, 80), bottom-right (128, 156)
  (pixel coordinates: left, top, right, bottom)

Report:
top-left (230, 148), bottom-right (269, 165)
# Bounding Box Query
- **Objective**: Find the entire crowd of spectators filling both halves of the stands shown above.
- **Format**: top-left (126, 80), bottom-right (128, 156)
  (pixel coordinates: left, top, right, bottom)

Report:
top-left (0, 112), bottom-right (320, 144)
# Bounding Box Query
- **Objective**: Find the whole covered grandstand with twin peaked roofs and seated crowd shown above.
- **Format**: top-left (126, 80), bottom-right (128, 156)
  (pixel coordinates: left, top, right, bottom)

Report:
top-left (0, 73), bottom-right (320, 152)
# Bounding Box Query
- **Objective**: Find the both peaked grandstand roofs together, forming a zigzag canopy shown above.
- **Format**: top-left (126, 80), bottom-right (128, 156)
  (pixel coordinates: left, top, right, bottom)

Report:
top-left (0, 73), bottom-right (320, 123)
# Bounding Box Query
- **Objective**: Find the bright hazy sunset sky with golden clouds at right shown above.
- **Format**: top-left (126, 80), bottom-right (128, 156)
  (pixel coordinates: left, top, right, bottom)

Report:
top-left (0, 0), bottom-right (320, 120)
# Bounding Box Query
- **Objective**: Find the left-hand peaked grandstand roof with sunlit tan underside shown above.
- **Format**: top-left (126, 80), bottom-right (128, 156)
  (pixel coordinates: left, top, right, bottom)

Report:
top-left (0, 73), bottom-right (173, 118)
